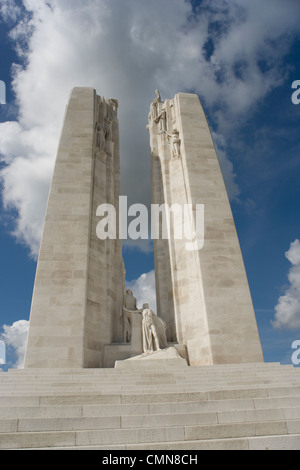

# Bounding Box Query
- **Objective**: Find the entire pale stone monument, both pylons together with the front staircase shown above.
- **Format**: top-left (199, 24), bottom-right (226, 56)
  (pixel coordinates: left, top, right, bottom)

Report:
top-left (4, 88), bottom-right (300, 454)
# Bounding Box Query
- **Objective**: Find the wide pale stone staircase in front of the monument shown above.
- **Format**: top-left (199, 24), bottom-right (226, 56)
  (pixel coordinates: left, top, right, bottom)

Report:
top-left (0, 363), bottom-right (300, 451)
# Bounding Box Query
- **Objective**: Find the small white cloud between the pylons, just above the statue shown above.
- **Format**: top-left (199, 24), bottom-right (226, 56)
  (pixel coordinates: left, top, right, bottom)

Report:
top-left (126, 271), bottom-right (156, 313)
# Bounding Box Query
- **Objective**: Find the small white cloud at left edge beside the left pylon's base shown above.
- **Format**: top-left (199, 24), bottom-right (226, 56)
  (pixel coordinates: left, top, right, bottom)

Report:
top-left (1, 320), bottom-right (29, 369)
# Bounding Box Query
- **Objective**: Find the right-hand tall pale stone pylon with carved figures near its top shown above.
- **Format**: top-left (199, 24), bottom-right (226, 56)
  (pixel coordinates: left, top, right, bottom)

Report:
top-left (148, 92), bottom-right (263, 365)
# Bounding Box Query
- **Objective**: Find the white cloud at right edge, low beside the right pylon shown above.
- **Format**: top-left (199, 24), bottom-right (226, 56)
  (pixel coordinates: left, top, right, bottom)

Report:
top-left (272, 240), bottom-right (300, 329)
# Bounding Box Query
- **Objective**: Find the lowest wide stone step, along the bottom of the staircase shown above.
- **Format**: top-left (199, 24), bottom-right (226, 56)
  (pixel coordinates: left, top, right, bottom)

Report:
top-left (0, 420), bottom-right (300, 449)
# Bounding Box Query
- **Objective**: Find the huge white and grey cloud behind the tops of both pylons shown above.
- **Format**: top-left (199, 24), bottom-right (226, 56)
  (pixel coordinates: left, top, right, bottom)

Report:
top-left (0, 0), bottom-right (300, 255)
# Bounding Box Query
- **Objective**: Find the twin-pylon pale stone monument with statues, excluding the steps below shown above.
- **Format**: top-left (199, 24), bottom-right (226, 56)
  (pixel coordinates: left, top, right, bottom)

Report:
top-left (25, 88), bottom-right (263, 368)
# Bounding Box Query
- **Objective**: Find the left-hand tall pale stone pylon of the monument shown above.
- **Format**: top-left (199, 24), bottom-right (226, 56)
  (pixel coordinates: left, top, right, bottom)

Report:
top-left (25, 88), bottom-right (124, 368)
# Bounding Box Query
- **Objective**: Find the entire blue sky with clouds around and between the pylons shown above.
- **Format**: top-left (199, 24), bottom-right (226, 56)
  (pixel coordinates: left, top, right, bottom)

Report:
top-left (0, 0), bottom-right (300, 366)
